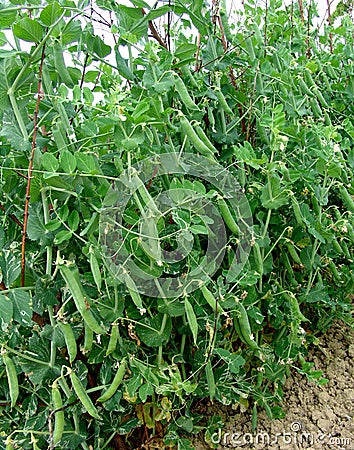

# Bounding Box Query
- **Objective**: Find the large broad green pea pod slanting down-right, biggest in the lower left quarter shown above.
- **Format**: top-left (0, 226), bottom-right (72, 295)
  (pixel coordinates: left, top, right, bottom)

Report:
top-left (59, 264), bottom-right (105, 334)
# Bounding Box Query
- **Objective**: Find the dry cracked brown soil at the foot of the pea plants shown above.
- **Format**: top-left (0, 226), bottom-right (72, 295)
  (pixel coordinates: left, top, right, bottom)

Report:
top-left (194, 324), bottom-right (354, 450)
